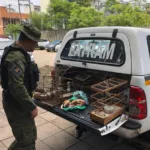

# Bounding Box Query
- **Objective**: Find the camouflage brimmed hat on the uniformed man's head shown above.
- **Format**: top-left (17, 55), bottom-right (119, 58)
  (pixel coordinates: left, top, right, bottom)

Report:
top-left (20, 24), bottom-right (41, 42)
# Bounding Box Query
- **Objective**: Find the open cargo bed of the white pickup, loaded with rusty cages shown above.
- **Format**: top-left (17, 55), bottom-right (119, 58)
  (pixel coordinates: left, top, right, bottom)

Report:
top-left (35, 66), bottom-right (140, 135)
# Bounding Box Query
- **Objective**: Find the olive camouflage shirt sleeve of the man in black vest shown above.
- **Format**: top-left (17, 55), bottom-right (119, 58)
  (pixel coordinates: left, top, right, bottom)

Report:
top-left (5, 44), bottom-right (36, 112)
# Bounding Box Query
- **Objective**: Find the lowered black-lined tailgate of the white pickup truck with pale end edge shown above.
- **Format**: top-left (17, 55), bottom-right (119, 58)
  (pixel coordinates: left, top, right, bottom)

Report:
top-left (35, 100), bottom-right (128, 136)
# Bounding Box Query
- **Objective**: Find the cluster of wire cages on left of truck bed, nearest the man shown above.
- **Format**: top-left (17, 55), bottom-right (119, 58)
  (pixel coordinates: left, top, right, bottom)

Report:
top-left (34, 66), bottom-right (71, 107)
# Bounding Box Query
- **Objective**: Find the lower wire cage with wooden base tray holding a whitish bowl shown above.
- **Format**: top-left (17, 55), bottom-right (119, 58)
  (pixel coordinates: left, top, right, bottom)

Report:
top-left (90, 91), bottom-right (128, 125)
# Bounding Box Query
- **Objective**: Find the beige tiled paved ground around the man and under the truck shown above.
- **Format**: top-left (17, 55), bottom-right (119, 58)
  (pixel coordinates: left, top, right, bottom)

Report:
top-left (0, 51), bottom-right (137, 150)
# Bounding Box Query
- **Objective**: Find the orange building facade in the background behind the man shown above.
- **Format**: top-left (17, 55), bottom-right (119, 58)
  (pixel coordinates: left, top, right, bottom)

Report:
top-left (0, 6), bottom-right (29, 34)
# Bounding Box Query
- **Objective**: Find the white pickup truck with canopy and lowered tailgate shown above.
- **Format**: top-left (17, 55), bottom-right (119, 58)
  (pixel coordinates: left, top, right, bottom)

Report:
top-left (35, 27), bottom-right (150, 138)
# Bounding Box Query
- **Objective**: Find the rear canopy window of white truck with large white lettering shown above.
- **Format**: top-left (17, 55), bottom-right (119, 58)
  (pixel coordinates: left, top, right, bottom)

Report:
top-left (61, 39), bottom-right (125, 66)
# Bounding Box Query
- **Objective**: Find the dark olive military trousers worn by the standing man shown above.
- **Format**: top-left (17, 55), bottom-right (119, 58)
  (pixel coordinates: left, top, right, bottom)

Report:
top-left (3, 100), bottom-right (37, 150)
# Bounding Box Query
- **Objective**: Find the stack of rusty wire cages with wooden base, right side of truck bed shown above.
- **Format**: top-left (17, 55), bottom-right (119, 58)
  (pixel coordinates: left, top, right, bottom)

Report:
top-left (90, 78), bottom-right (129, 125)
